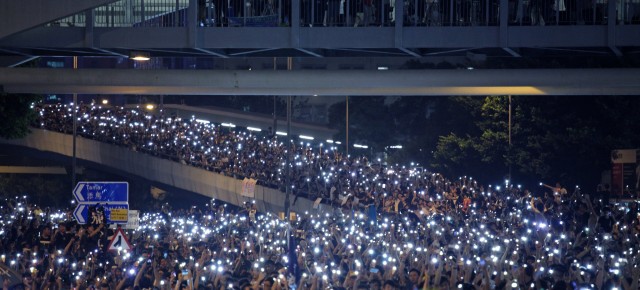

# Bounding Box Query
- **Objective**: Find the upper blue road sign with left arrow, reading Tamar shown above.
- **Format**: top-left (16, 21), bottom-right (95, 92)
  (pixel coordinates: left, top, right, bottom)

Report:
top-left (73, 182), bottom-right (129, 204)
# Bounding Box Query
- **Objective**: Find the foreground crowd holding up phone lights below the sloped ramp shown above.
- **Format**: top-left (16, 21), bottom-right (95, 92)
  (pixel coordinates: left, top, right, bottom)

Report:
top-left (0, 182), bottom-right (640, 289)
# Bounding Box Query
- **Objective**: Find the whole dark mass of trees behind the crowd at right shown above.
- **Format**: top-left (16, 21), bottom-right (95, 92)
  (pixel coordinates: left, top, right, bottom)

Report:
top-left (329, 96), bottom-right (640, 186)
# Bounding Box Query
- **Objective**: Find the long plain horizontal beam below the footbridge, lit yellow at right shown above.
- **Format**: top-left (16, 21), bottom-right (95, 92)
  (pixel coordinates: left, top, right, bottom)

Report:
top-left (0, 68), bottom-right (640, 96)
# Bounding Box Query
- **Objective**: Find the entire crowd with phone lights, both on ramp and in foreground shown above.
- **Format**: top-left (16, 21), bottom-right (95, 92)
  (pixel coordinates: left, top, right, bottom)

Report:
top-left (0, 101), bottom-right (640, 290)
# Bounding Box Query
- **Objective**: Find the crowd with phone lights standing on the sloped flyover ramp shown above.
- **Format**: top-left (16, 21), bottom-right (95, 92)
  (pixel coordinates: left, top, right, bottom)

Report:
top-left (36, 104), bottom-right (422, 201)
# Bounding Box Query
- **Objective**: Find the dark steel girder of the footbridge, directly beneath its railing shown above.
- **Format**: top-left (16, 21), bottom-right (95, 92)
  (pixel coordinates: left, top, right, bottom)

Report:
top-left (5, 26), bottom-right (640, 51)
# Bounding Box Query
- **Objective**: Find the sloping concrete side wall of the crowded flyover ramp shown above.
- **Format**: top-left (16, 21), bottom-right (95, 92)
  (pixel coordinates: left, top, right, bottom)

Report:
top-left (0, 129), bottom-right (330, 212)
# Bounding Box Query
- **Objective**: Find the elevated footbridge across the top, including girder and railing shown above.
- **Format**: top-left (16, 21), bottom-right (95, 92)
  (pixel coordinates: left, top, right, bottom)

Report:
top-left (0, 0), bottom-right (640, 59)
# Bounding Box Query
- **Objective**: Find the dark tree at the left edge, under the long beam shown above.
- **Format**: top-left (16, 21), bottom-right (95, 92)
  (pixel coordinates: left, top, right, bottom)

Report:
top-left (0, 94), bottom-right (41, 139)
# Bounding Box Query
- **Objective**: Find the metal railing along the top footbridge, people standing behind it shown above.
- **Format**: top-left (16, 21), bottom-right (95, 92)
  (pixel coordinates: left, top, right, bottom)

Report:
top-left (49, 0), bottom-right (640, 27)
